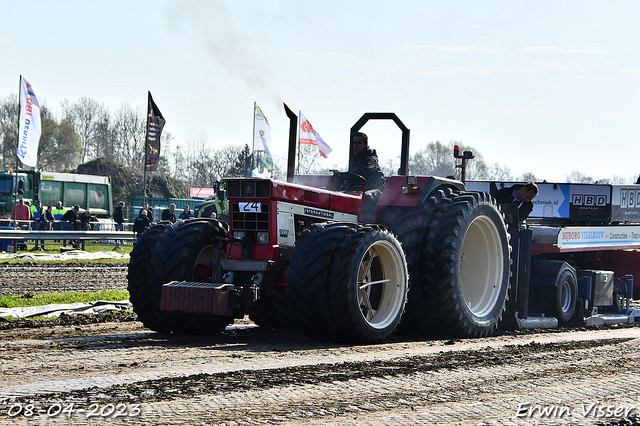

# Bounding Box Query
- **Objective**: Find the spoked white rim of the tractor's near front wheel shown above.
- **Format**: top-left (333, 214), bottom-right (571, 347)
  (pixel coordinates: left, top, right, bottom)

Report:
top-left (357, 240), bottom-right (407, 329)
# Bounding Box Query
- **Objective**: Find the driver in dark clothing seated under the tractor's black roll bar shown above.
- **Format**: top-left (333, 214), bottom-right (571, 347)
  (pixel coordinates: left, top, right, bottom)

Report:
top-left (349, 132), bottom-right (387, 223)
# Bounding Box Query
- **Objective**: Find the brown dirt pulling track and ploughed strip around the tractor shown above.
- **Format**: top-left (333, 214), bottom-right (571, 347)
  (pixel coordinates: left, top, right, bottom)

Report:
top-left (0, 264), bottom-right (640, 425)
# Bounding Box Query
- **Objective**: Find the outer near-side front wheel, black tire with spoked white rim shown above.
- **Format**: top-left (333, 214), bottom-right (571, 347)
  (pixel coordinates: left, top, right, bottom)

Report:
top-left (330, 225), bottom-right (409, 343)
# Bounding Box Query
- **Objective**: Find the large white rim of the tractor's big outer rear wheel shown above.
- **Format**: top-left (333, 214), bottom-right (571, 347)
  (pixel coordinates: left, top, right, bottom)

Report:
top-left (460, 216), bottom-right (504, 318)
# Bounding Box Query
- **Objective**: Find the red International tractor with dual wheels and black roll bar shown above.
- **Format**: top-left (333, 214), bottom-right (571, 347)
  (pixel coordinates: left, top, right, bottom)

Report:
top-left (128, 113), bottom-right (511, 343)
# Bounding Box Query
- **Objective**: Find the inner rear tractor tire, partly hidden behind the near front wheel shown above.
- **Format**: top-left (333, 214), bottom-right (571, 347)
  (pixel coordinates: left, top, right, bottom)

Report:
top-left (378, 188), bottom-right (451, 334)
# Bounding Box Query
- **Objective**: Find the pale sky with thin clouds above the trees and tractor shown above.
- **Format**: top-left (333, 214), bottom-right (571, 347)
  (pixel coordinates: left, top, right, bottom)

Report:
top-left (0, 0), bottom-right (640, 181)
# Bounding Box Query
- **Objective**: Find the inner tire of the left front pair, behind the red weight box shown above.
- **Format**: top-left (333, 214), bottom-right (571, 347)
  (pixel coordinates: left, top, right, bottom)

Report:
top-left (147, 218), bottom-right (233, 334)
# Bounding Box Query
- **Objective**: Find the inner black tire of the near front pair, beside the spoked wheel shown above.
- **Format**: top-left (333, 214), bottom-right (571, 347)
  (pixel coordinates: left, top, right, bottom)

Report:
top-left (286, 223), bottom-right (357, 340)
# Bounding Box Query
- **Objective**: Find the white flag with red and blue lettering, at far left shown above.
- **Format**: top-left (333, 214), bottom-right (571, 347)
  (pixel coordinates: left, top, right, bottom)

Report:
top-left (17, 77), bottom-right (42, 167)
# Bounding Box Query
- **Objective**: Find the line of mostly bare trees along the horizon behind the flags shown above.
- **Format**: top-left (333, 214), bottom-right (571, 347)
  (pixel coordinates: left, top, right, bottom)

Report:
top-left (0, 94), bottom-right (628, 187)
